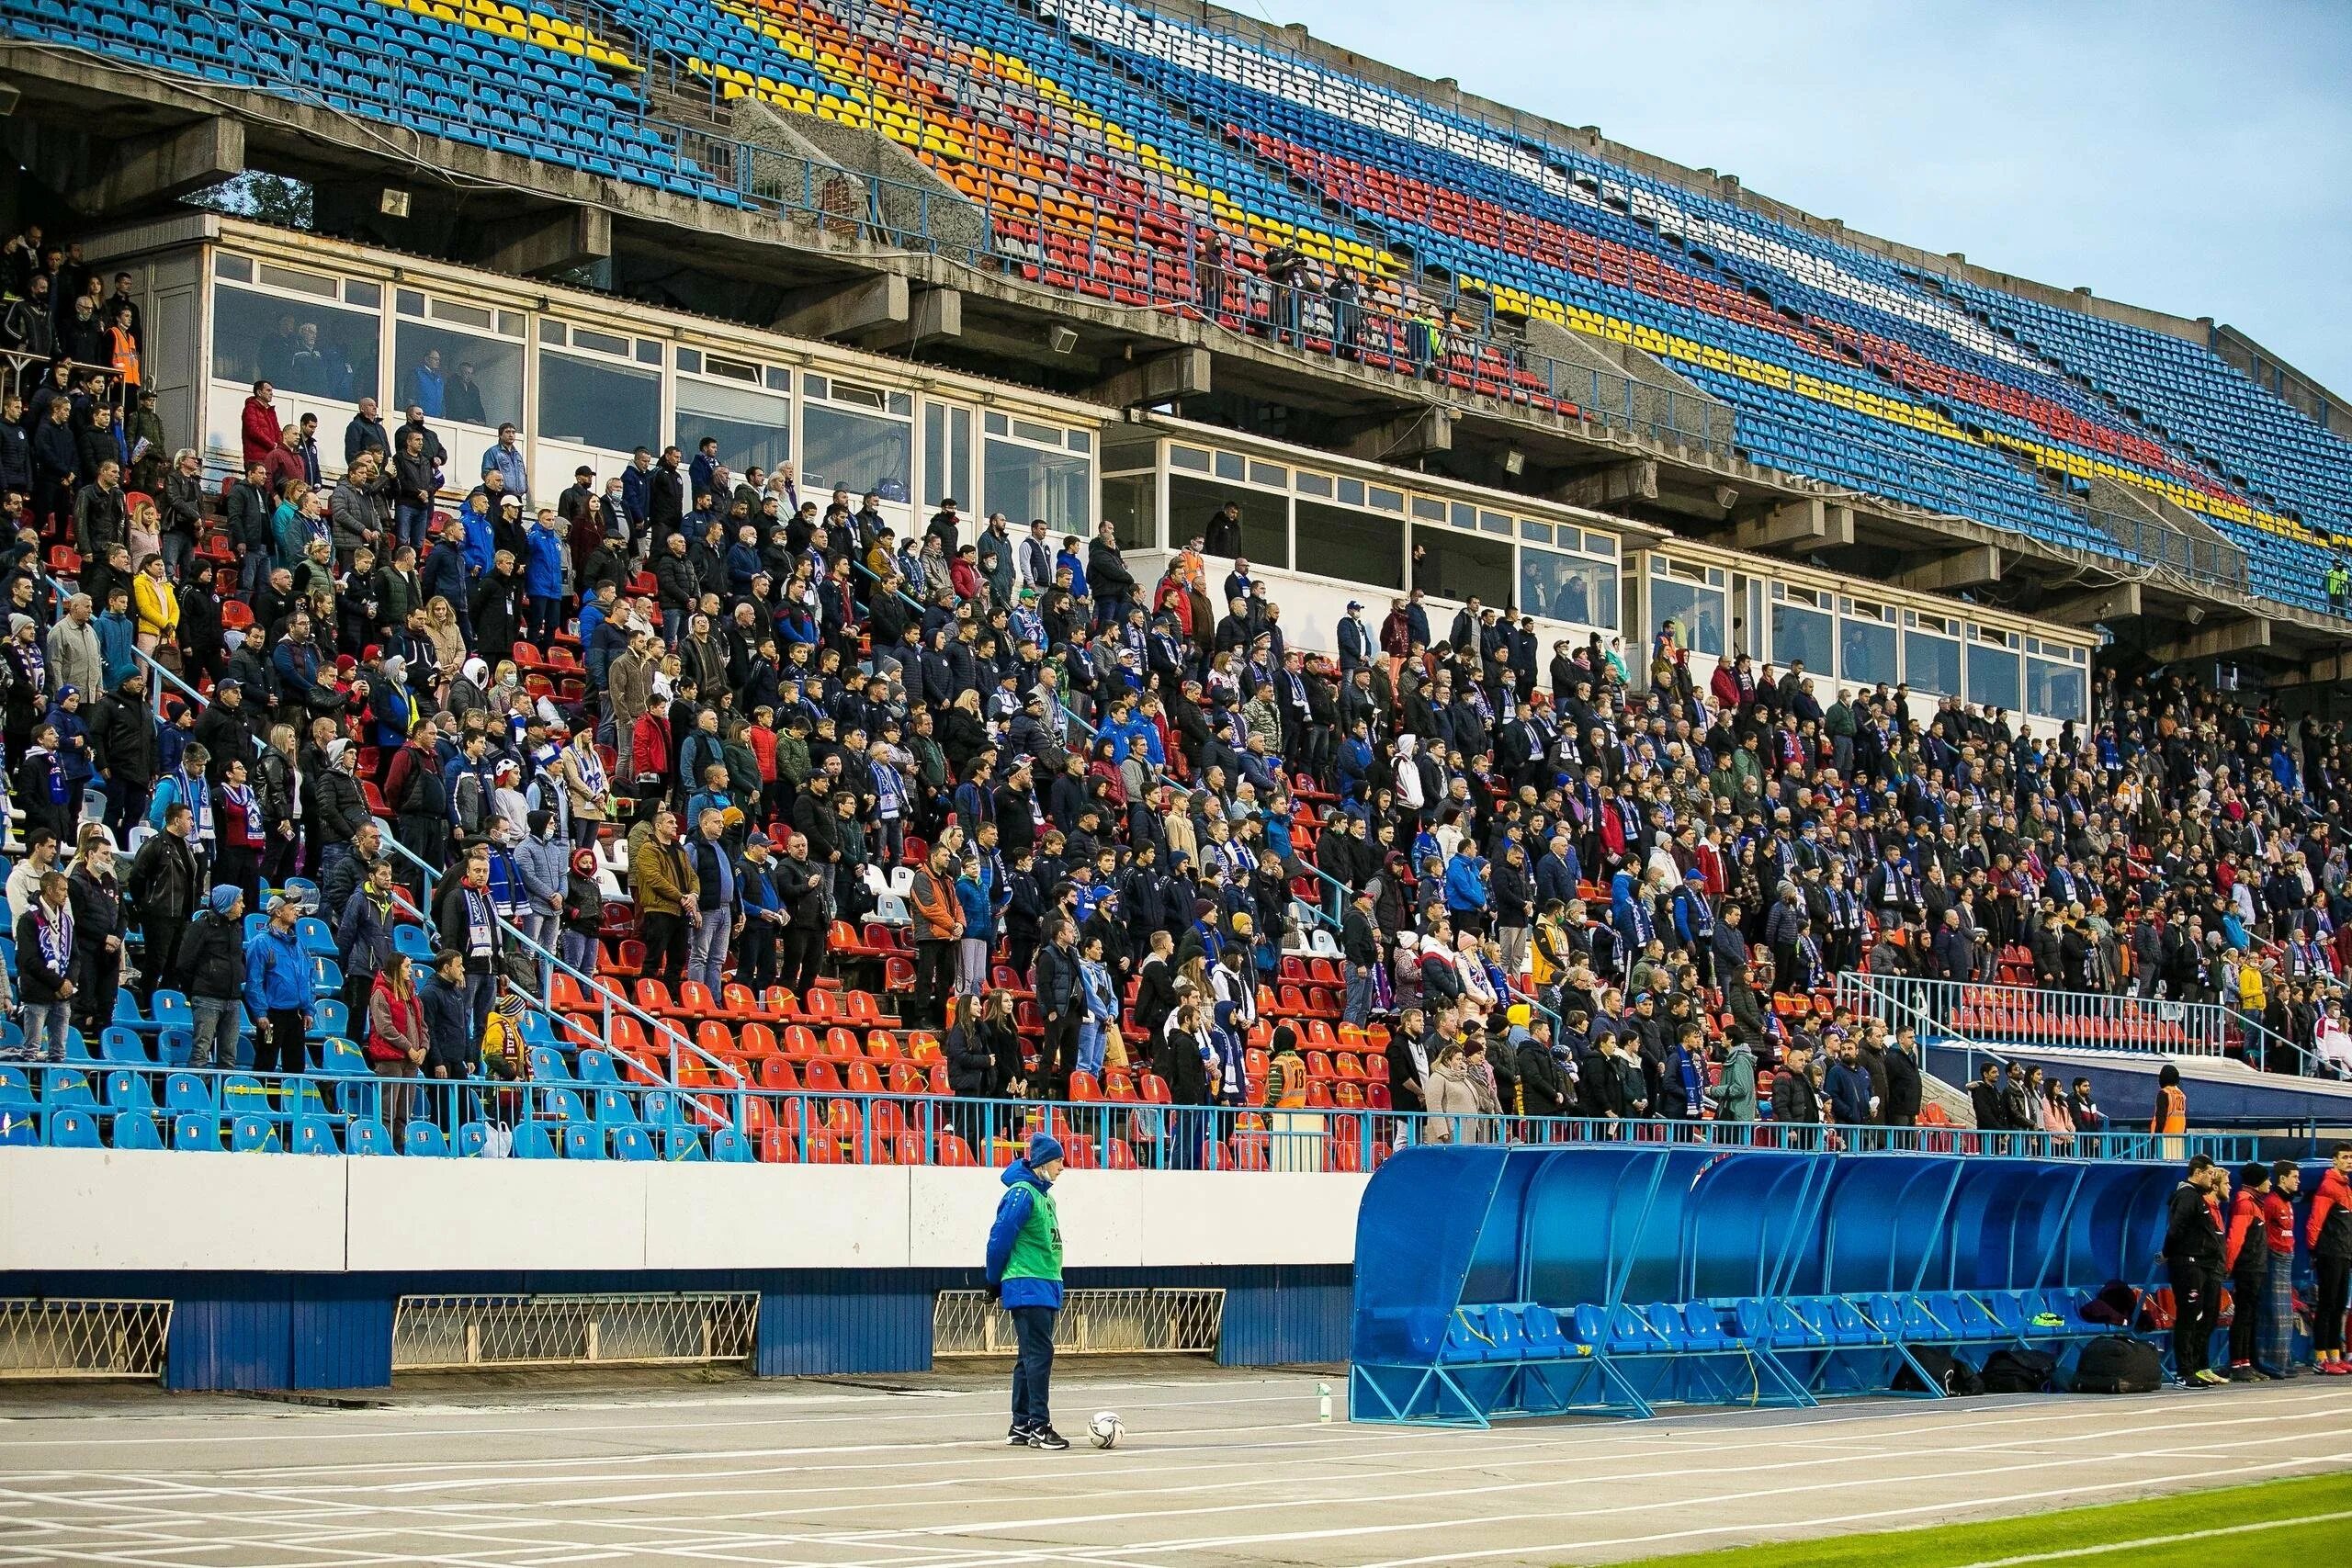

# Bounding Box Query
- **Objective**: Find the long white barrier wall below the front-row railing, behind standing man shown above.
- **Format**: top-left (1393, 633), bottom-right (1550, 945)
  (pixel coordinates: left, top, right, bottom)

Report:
top-left (0, 1149), bottom-right (1366, 1274)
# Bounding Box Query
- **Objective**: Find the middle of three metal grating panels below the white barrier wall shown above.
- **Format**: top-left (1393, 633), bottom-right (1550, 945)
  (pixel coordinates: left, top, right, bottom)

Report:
top-left (393, 1291), bottom-right (760, 1373)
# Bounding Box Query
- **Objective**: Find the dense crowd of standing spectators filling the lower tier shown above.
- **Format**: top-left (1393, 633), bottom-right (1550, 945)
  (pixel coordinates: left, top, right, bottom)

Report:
top-left (0, 215), bottom-right (2352, 1142)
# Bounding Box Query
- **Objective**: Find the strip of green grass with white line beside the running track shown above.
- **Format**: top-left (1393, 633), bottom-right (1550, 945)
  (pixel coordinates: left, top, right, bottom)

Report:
top-left (1589, 1474), bottom-right (2352, 1568)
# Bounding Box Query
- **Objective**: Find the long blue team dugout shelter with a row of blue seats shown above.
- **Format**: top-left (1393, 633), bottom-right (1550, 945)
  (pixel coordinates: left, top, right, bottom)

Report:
top-left (1350, 1145), bottom-right (2178, 1427)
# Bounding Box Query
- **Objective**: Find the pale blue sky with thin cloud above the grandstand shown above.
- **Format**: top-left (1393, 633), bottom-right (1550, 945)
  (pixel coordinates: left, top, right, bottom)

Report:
top-left (1223, 0), bottom-right (2352, 400)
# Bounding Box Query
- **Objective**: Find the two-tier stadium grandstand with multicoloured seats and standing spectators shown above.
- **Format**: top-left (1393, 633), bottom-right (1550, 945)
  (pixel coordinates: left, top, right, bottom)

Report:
top-left (0, 0), bottom-right (2352, 1485)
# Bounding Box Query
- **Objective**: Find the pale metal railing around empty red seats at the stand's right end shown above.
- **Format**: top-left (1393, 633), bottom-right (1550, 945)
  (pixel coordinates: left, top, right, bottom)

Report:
top-left (1837, 974), bottom-right (2312, 1075)
